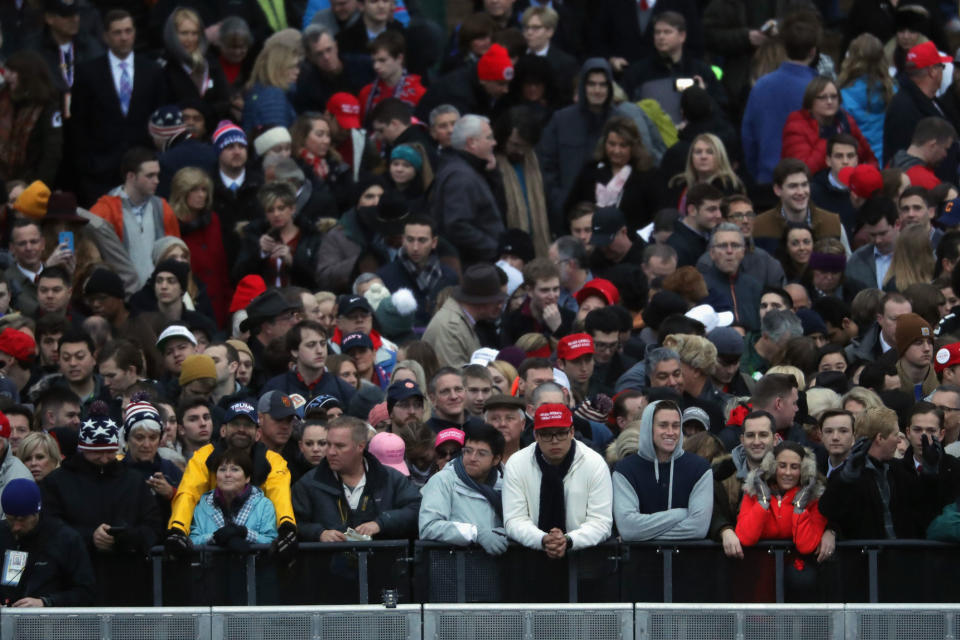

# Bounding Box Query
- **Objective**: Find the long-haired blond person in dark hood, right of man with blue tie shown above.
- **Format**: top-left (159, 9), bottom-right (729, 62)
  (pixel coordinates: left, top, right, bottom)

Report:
top-left (163, 7), bottom-right (230, 109)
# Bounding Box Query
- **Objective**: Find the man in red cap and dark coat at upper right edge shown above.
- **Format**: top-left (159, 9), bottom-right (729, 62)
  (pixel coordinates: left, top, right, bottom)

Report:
top-left (882, 41), bottom-right (952, 166)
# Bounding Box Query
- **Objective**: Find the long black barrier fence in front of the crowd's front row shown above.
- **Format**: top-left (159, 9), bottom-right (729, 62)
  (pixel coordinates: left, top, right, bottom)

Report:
top-left (131, 540), bottom-right (960, 606)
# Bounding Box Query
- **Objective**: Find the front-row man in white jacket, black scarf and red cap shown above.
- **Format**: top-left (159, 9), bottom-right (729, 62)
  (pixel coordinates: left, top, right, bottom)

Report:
top-left (503, 404), bottom-right (613, 559)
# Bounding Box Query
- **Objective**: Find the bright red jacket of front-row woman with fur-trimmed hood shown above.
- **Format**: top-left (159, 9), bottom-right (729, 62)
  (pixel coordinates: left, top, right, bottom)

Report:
top-left (734, 487), bottom-right (827, 554)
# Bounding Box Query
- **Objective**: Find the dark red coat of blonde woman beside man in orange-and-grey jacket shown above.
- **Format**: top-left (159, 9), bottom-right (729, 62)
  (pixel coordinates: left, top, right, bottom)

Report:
top-left (181, 211), bottom-right (233, 327)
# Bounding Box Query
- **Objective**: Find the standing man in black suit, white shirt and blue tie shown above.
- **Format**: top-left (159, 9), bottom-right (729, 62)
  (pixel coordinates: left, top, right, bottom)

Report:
top-left (71, 9), bottom-right (164, 206)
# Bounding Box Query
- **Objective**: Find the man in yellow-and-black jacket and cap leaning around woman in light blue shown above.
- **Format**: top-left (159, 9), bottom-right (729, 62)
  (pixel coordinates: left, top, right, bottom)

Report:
top-left (166, 401), bottom-right (297, 559)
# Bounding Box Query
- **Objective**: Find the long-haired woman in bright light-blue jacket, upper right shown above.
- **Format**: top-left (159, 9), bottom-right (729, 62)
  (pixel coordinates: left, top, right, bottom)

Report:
top-left (837, 33), bottom-right (897, 160)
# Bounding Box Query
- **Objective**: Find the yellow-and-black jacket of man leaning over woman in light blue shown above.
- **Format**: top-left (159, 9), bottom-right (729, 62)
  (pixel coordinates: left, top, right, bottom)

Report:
top-left (167, 442), bottom-right (297, 535)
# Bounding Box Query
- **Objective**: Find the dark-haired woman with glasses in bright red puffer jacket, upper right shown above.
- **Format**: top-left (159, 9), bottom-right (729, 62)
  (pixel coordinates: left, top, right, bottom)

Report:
top-left (780, 76), bottom-right (877, 173)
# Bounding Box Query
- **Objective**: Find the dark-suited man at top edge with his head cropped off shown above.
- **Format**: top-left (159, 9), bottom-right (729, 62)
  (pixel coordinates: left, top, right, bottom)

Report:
top-left (589, 0), bottom-right (703, 73)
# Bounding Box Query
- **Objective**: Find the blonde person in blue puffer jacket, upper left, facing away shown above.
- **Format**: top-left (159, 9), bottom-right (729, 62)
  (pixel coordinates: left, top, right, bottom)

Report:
top-left (242, 37), bottom-right (303, 135)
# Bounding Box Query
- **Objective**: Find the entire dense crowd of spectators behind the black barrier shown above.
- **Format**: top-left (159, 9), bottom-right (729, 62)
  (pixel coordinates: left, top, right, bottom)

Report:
top-left (0, 0), bottom-right (960, 606)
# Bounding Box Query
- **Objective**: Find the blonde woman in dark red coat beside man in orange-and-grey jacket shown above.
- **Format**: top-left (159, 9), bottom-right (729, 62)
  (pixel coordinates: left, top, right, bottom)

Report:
top-left (170, 167), bottom-right (233, 327)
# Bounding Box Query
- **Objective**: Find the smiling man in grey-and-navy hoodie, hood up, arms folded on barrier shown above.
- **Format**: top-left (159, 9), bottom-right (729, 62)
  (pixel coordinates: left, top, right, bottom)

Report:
top-left (613, 400), bottom-right (713, 542)
